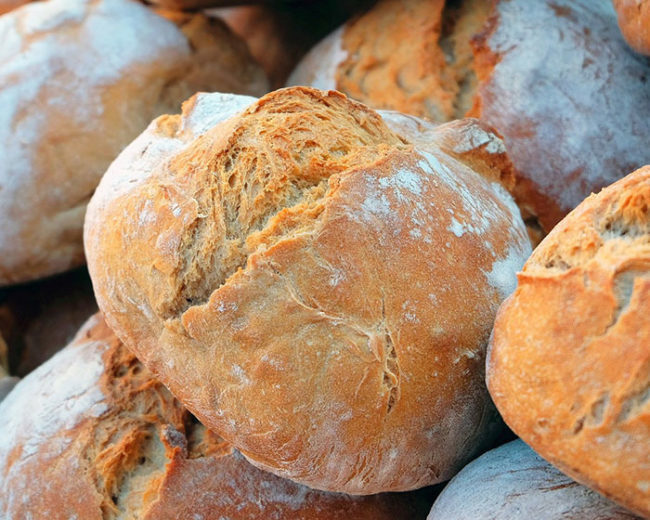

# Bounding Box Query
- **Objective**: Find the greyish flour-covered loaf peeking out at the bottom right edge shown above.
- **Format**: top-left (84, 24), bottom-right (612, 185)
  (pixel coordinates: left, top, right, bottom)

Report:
top-left (428, 440), bottom-right (633, 520)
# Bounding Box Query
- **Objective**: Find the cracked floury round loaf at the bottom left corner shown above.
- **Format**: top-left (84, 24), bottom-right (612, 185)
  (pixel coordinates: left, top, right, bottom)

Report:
top-left (0, 315), bottom-right (426, 520)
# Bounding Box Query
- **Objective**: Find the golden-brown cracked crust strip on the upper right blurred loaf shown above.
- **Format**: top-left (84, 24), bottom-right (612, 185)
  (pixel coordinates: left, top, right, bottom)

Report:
top-left (336, 0), bottom-right (490, 122)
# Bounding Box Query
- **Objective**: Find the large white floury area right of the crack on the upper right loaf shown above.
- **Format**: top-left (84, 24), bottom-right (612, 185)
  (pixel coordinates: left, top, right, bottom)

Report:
top-left (481, 0), bottom-right (650, 215)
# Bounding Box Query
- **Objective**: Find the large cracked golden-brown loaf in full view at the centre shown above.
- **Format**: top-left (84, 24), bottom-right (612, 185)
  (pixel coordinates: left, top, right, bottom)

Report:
top-left (85, 88), bottom-right (530, 494)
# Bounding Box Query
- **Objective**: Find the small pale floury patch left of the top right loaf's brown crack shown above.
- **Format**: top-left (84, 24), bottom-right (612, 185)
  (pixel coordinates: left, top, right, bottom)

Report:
top-left (287, 27), bottom-right (348, 90)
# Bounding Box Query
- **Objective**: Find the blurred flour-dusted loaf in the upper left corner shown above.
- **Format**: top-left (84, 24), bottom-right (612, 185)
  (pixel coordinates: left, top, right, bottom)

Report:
top-left (0, 0), bottom-right (265, 285)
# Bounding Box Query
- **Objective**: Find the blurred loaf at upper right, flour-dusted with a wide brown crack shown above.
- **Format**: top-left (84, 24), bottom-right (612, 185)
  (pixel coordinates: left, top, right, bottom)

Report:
top-left (289, 0), bottom-right (650, 232)
